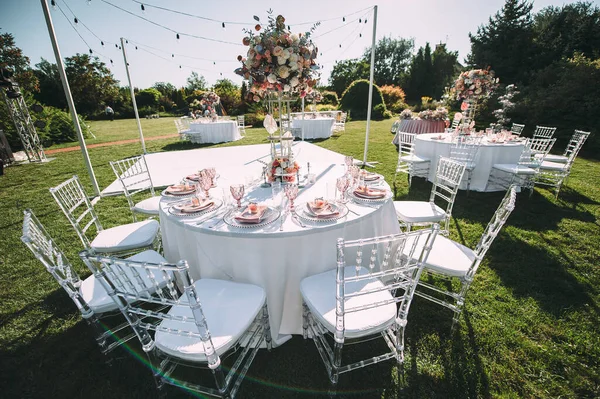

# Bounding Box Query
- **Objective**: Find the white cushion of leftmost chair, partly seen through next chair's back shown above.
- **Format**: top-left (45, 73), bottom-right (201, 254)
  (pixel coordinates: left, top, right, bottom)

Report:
top-left (79, 250), bottom-right (166, 313)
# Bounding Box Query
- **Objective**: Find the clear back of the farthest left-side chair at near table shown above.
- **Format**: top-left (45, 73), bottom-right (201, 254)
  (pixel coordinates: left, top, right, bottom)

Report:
top-left (110, 155), bottom-right (154, 216)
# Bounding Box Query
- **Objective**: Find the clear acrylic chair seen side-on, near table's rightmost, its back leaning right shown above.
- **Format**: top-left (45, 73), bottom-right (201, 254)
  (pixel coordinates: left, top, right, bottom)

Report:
top-left (415, 186), bottom-right (517, 327)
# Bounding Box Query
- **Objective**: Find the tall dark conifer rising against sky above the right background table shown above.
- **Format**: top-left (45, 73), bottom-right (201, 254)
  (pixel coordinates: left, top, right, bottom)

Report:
top-left (467, 0), bottom-right (534, 83)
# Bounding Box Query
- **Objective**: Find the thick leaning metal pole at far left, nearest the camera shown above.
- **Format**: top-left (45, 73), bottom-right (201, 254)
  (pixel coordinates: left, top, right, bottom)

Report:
top-left (40, 0), bottom-right (100, 197)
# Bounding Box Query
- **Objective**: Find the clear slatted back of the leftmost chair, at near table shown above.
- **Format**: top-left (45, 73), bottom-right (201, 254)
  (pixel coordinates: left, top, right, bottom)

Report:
top-left (21, 209), bottom-right (94, 318)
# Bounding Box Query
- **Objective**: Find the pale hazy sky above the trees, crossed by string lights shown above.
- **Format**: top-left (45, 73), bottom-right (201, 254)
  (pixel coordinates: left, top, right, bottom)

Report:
top-left (0, 0), bottom-right (600, 88)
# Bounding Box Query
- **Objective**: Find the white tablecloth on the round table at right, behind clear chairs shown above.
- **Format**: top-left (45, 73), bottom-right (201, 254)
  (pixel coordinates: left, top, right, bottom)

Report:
top-left (414, 133), bottom-right (524, 191)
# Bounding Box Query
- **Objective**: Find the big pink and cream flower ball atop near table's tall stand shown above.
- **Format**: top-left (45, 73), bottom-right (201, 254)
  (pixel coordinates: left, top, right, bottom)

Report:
top-left (235, 10), bottom-right (319, 102)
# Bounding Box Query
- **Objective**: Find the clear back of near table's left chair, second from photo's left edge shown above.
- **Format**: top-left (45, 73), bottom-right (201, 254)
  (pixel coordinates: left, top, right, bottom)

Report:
top-left (50, 176), bottom-right (102, 248)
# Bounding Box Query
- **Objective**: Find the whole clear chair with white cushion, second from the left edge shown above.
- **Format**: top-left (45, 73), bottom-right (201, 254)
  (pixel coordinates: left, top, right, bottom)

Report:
top-left (50, 176), bottom-right (160, 254)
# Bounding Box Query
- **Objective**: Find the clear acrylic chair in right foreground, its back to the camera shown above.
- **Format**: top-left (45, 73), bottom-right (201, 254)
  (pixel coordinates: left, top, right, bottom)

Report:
top-left (300, 225), bottom-right (438, 384)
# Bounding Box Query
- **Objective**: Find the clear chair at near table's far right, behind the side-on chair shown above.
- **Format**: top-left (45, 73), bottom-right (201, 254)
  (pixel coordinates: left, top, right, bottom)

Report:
top-left (394, 157), bottom-right (465, 236)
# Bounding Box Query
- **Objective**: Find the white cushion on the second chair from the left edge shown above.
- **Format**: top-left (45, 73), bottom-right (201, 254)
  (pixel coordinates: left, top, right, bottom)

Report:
top-left (91, 220), bottom-right (159, 252)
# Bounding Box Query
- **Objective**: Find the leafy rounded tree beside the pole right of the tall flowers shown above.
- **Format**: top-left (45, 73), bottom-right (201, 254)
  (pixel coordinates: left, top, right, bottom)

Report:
top-left (362, 36), bottom-right (415, 86)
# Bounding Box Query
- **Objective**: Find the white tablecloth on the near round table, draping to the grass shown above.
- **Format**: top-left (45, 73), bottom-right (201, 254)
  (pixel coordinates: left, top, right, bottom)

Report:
top-left (160, 159), bottom-right (400, 345)
